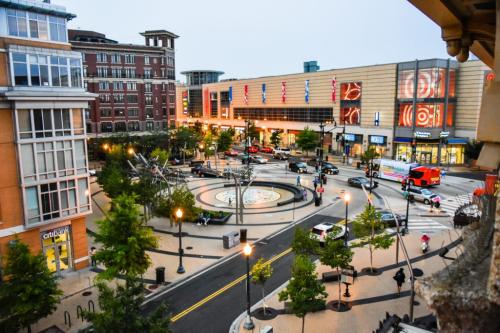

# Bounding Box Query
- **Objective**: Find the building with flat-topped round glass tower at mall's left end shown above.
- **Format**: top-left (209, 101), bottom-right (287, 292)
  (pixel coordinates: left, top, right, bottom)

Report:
top-left (176, 70), bottom-right (224, 118)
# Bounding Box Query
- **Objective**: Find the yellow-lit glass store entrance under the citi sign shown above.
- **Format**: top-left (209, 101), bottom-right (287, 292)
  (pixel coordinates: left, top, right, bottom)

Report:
top-left (42, 226), bottom-right (73, 275)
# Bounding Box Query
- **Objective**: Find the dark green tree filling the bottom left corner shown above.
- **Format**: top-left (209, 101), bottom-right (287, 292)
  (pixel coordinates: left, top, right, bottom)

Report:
top-left (0, 239), bottom-right (62, 332)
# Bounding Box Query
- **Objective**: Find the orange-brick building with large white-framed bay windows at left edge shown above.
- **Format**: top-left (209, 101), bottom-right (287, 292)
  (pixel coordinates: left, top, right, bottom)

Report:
top-left (0, 0), bottom-right (95, 273)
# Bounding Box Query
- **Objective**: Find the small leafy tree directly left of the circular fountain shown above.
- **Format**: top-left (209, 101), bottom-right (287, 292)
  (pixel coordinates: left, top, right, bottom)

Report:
top-left (157, 185), bottom-right (199, 226)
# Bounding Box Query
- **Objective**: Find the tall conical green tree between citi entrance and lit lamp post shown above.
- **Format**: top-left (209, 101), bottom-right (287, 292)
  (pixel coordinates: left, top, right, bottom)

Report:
top-left (95, 194), bottom-right (158, 279)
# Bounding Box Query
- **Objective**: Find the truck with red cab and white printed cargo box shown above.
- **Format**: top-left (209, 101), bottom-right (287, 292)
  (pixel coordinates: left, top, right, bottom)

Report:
top-left (365, 159), bottom-right (441, 187)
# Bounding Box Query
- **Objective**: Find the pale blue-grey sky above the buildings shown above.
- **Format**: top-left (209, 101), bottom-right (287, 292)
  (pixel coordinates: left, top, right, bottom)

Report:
top-left (52, 0), bottom-right (448, 82)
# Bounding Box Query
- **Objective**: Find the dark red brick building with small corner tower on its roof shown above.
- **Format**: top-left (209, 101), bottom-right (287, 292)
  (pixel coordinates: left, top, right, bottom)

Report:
top-left (69, 30), bottom-right (178, 138)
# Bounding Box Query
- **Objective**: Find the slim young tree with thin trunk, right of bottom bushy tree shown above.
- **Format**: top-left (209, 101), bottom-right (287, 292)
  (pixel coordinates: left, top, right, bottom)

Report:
top-left (320, 232), bottom-right (354, 310)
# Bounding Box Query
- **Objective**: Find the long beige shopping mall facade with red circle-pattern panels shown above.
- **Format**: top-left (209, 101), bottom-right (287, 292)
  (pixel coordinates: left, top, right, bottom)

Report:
top-left (176, 59), bottom-right (490, 165)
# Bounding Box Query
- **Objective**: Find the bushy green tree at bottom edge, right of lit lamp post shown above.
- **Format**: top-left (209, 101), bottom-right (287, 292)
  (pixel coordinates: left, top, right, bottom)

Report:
top-left (279, 255), bottom-right (328, 333)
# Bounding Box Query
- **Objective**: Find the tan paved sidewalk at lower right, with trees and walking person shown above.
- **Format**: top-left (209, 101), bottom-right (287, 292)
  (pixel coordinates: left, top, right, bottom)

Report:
top-left (230, 228), bottom-right (458, 333)
